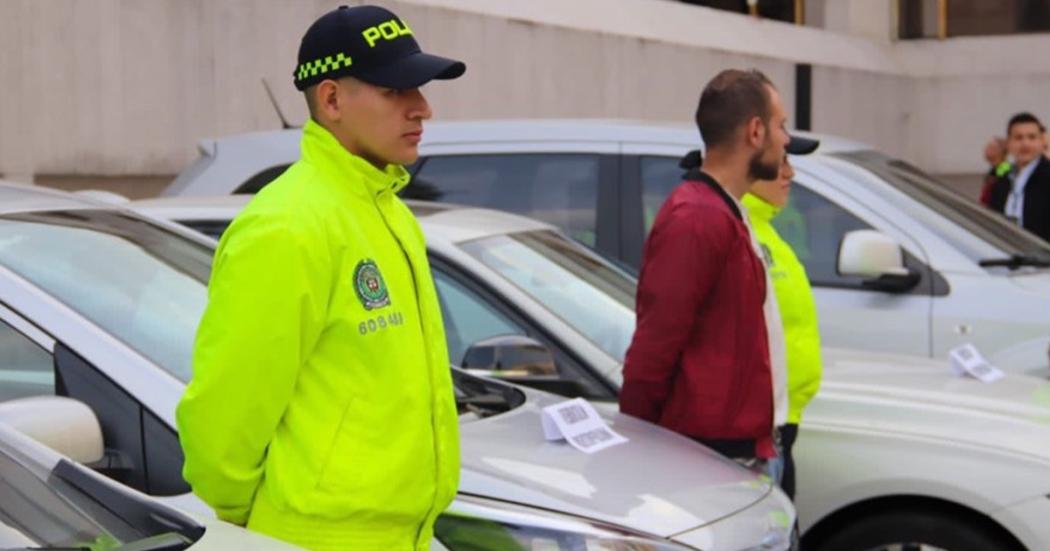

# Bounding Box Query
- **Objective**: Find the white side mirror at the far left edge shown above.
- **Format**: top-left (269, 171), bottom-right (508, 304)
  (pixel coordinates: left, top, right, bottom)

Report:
top-left (0, 396), bottom-right (104, 463)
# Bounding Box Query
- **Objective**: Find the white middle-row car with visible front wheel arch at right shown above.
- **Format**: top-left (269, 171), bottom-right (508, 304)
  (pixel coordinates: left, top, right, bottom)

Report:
top-left (141, 196), bottom-right (1050, 551)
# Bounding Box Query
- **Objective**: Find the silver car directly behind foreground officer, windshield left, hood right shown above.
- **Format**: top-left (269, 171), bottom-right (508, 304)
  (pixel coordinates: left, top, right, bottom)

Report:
top-left (0, 185), bottom-right (795, 551)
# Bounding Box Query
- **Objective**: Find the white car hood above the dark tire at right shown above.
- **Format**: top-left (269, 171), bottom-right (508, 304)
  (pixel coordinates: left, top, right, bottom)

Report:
top-left (802, 348), bottom-right (1050, 464)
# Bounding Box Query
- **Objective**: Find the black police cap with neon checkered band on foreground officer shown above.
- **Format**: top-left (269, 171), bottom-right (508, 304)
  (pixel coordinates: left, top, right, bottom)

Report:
top-left (293, 5), bottom-right (466, 90)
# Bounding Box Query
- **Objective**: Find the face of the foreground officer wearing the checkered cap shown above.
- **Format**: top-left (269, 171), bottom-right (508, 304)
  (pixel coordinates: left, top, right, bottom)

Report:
top-left (321, 78), bottom-right (432, 168)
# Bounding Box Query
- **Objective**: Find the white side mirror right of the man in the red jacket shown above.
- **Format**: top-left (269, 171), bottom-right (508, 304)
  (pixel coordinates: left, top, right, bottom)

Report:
top-left (838, 230), bottom-right (920, 293)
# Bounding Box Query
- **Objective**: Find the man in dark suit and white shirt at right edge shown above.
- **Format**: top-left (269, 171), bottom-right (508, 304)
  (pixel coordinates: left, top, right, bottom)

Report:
top-left (988, 112), bottom-right (1050, 242)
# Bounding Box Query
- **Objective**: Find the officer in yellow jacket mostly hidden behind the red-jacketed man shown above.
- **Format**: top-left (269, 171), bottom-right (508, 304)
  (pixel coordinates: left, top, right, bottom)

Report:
top-left (742, 136), bottom-right (822, 499)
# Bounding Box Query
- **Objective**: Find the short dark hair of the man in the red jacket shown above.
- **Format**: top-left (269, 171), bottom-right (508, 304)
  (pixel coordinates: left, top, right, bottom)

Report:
top-left (696, 69), bottom-right (774, 148)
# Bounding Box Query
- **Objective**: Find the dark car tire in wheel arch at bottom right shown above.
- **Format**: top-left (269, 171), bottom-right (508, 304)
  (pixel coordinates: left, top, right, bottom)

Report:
top-left (816, 511), bottom-right (1017, 551)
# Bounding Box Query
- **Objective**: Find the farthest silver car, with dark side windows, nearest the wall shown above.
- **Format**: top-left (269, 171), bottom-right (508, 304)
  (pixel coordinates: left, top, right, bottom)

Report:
top-left (159, 120), bottom-right (1050, 376)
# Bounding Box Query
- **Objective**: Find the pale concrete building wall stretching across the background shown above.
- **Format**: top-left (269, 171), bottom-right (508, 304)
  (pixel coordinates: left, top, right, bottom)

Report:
top-left (0, 0), bottom-right (1050, 193)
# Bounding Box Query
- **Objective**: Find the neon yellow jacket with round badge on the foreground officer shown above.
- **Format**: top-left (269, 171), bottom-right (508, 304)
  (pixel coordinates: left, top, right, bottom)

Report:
top-left (176, 122), bottom-right (460, 550)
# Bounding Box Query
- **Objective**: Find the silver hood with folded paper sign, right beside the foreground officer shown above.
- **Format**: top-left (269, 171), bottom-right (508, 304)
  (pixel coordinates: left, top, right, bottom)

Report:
top-left (460, 389), bottom-right (771, 537)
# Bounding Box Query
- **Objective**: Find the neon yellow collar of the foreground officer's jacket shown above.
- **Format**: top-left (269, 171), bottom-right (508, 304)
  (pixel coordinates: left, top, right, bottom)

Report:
top-left (301, 119), bottom-right (411, 198)
